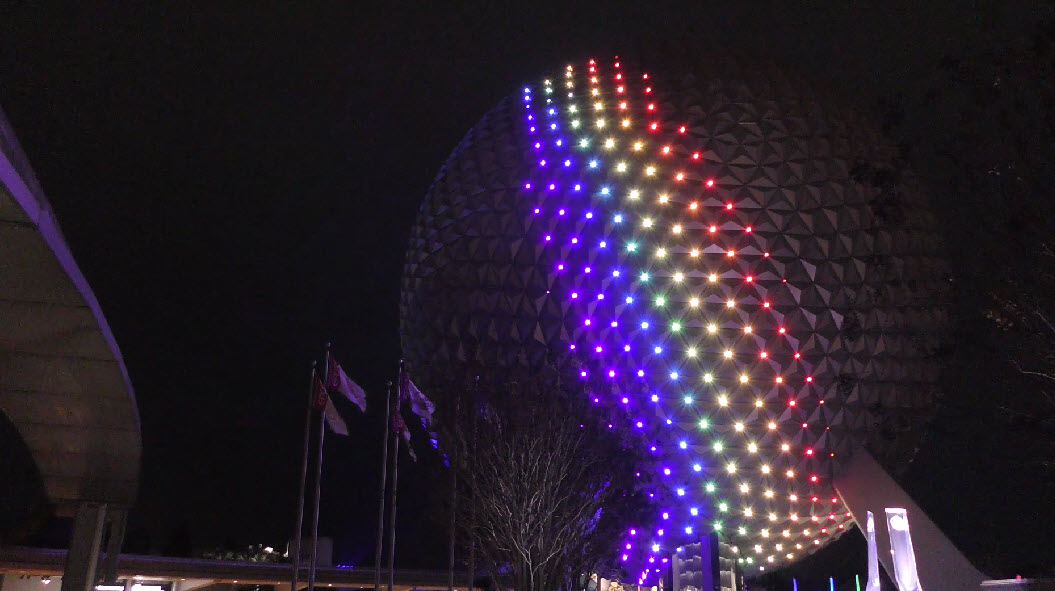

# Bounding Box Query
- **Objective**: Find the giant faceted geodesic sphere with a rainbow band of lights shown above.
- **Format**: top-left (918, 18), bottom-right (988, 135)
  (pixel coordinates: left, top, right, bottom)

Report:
top-left (401, 58), bottom-right (946, 585)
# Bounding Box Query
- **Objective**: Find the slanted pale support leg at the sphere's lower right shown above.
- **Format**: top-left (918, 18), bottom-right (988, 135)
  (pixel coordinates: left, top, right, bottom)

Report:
top-left (835, 450), bottom-right (985, 591)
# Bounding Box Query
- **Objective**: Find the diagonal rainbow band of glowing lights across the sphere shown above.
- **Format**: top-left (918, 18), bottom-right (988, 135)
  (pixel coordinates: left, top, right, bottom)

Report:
top-left (520, 57), bottom-right (850, 585)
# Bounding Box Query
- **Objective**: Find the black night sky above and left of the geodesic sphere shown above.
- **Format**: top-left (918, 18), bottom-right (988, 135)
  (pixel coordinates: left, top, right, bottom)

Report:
top-left (0, 2), bottom-right (1050, 578)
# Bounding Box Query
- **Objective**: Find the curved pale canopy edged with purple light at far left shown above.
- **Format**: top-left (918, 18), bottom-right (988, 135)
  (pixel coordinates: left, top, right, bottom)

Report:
top-left (0, 106), bottom-right (142, 507)
